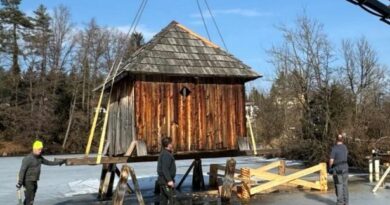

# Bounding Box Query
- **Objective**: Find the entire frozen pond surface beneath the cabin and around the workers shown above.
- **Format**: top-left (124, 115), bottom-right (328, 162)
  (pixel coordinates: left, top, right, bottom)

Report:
top-left (0, 155), bottom-right (390, 205)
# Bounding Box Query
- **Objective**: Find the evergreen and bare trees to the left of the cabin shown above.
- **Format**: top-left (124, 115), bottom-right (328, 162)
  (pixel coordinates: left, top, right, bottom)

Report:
top-left (0, 0), bottom-right (144, 153)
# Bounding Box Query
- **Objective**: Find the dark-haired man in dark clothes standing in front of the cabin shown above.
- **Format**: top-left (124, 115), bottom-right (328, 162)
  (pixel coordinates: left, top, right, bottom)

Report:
top-left (157, 137), bottom-right (176, 205)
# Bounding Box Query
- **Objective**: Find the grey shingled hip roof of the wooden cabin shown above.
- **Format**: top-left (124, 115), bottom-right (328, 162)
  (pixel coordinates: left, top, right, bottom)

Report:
top-left (103, 21), bottom-right (261, 88)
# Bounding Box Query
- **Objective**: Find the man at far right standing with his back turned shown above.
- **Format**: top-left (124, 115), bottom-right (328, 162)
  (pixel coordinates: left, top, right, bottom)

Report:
top-left (329, 133), bottom-right (349, 205)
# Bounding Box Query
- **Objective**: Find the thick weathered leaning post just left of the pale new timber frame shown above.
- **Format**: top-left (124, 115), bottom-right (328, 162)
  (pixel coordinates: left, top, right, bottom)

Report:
top-left (221, 158), bottom-right (236, 202)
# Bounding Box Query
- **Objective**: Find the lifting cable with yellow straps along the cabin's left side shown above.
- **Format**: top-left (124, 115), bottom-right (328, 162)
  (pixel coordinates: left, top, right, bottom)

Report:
top-left (85, 0), bottom-right (148, 160)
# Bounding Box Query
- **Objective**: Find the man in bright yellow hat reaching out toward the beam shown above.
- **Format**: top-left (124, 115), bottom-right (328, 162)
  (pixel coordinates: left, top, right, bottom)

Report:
top-left (16, 140), bottom-right (66, 205)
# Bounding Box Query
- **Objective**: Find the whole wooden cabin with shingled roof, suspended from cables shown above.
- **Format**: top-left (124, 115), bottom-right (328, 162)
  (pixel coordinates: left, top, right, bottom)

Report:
top-left (107, 21), bottom-right (261, 156)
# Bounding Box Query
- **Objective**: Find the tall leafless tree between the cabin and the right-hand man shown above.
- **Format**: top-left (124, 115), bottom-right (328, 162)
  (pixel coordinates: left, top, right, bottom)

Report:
top-left (270, 16), bottom-right (333, 144)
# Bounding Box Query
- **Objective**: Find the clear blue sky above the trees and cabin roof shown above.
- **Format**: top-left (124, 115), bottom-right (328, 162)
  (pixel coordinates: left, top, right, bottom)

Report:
top-left (21, 0), bottom-right (390, 90)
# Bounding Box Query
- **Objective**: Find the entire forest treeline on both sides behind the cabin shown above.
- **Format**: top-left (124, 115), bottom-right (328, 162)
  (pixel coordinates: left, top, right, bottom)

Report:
top-left (0, 0), bottom-right (390, 166)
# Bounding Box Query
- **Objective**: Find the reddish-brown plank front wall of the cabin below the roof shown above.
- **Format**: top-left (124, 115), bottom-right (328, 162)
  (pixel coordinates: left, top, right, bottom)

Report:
top-left (134, 76), bottom-right (246, 153)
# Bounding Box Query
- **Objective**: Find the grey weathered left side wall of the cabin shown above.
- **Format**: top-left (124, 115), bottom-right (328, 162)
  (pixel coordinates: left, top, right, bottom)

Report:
top-left (107, 78), bottom-right (135, 155)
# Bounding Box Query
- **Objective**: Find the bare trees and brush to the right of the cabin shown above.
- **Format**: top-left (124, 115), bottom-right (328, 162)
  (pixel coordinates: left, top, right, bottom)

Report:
top-left (248, 15), bottom-right (390, 166)
